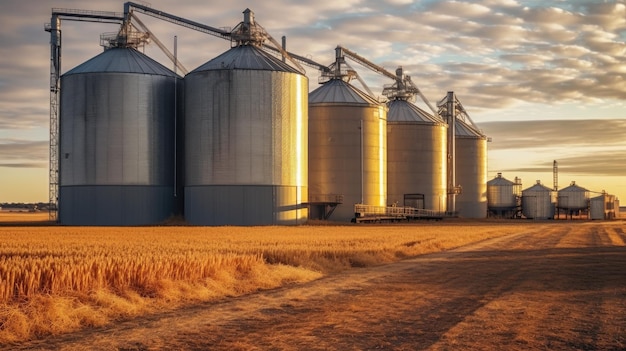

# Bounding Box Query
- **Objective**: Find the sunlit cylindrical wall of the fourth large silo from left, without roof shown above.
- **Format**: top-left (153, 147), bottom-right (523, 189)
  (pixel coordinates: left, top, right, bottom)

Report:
top-left (387, 122), bottom-right (447, 211)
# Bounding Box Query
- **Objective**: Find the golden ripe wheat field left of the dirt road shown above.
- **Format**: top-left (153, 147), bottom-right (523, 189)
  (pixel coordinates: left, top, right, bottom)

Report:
top-left (0, 221), bottom-right (538, 345)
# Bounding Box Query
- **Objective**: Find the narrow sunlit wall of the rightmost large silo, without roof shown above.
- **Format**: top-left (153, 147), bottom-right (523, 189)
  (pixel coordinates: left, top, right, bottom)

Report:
top-left (455, 137), bottom-right (487, 218)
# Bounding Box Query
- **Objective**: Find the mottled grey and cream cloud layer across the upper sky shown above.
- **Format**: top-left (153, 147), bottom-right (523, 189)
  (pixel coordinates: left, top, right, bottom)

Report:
top-left (0, 0), bottom-right (626, 118)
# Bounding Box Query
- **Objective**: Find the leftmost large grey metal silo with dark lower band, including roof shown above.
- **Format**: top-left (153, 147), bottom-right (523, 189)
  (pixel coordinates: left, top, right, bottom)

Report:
top-left (59, 47), bottom-right (182, 225)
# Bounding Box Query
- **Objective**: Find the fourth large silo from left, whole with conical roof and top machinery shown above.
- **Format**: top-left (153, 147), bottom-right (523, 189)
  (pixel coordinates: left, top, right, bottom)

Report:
top-left (383, 68), bottom-right (447, 211)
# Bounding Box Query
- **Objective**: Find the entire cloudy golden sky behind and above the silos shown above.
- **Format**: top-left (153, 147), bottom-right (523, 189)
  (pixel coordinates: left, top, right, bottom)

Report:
top-left (0, 0), bottom-right (626, 204)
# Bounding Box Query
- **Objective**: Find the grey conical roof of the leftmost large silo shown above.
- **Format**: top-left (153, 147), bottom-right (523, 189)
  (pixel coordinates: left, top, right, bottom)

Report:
top-left (64, 48), bottom-right (178, 77)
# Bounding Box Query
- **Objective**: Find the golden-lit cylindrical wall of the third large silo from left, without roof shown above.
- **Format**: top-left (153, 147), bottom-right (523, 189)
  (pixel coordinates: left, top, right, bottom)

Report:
top-left (309, 103), bottom-right (387, 221)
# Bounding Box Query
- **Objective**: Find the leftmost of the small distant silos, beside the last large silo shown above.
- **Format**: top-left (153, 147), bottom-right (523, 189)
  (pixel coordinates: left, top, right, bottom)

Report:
top-left (487, 173), bottom-right (522, 218)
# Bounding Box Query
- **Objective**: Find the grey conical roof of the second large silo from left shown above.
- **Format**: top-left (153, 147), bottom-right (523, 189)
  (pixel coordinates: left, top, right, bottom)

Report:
top-left (190, 45), bottom-right (300, 73)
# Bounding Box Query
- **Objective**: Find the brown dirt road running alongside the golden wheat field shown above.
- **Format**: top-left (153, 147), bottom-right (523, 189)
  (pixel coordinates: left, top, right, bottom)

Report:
top-left (13, 221), bottom-right (626, 350)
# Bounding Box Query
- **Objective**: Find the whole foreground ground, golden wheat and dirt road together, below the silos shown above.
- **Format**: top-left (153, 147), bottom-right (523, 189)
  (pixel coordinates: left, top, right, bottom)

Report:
top-left (0, 210), bottom-right (626, 350)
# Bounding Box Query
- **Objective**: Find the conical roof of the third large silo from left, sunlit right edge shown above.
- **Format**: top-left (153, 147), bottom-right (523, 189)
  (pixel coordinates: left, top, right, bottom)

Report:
top-left (309, 79), bottom-right (379, 105)
